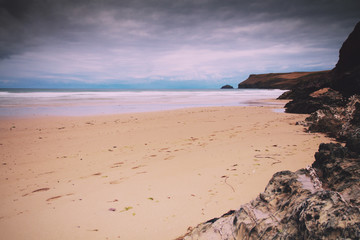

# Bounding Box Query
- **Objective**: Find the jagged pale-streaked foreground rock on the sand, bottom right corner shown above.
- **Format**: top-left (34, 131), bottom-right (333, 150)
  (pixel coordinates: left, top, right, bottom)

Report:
top-left (178, 144), bottom-right (360, 239)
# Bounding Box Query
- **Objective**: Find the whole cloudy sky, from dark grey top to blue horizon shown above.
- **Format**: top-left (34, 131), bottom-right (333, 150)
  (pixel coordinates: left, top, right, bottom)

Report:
top-left (0, 0), bottom-right (360, 89)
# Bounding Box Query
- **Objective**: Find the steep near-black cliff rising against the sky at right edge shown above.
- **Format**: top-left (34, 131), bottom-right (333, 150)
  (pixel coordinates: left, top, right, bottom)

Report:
top-left (332, 22), bottom-right (360, 96)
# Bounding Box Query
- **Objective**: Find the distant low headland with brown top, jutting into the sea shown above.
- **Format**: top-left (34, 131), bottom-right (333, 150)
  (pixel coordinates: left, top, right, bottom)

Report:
top-left (238, 71), bottom-right (330, 90)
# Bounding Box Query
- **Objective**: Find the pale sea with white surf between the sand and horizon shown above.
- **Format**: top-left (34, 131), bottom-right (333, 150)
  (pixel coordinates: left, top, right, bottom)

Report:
top-left (0, 89), bottom-right (284, 117)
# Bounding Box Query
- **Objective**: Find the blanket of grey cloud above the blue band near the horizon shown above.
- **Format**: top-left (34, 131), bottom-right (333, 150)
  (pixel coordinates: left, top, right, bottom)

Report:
top-left (0, 0), bottom-right (360, 86)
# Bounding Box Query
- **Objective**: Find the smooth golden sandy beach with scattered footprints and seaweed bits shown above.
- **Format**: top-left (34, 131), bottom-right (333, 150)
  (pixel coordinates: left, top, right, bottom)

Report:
top-left (0, 107), bottom-right (330, 240)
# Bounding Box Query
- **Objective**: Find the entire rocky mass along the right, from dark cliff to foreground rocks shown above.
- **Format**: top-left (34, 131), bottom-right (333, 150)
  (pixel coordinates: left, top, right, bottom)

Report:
top-left (178, 22), bottom-right (360, 239)
